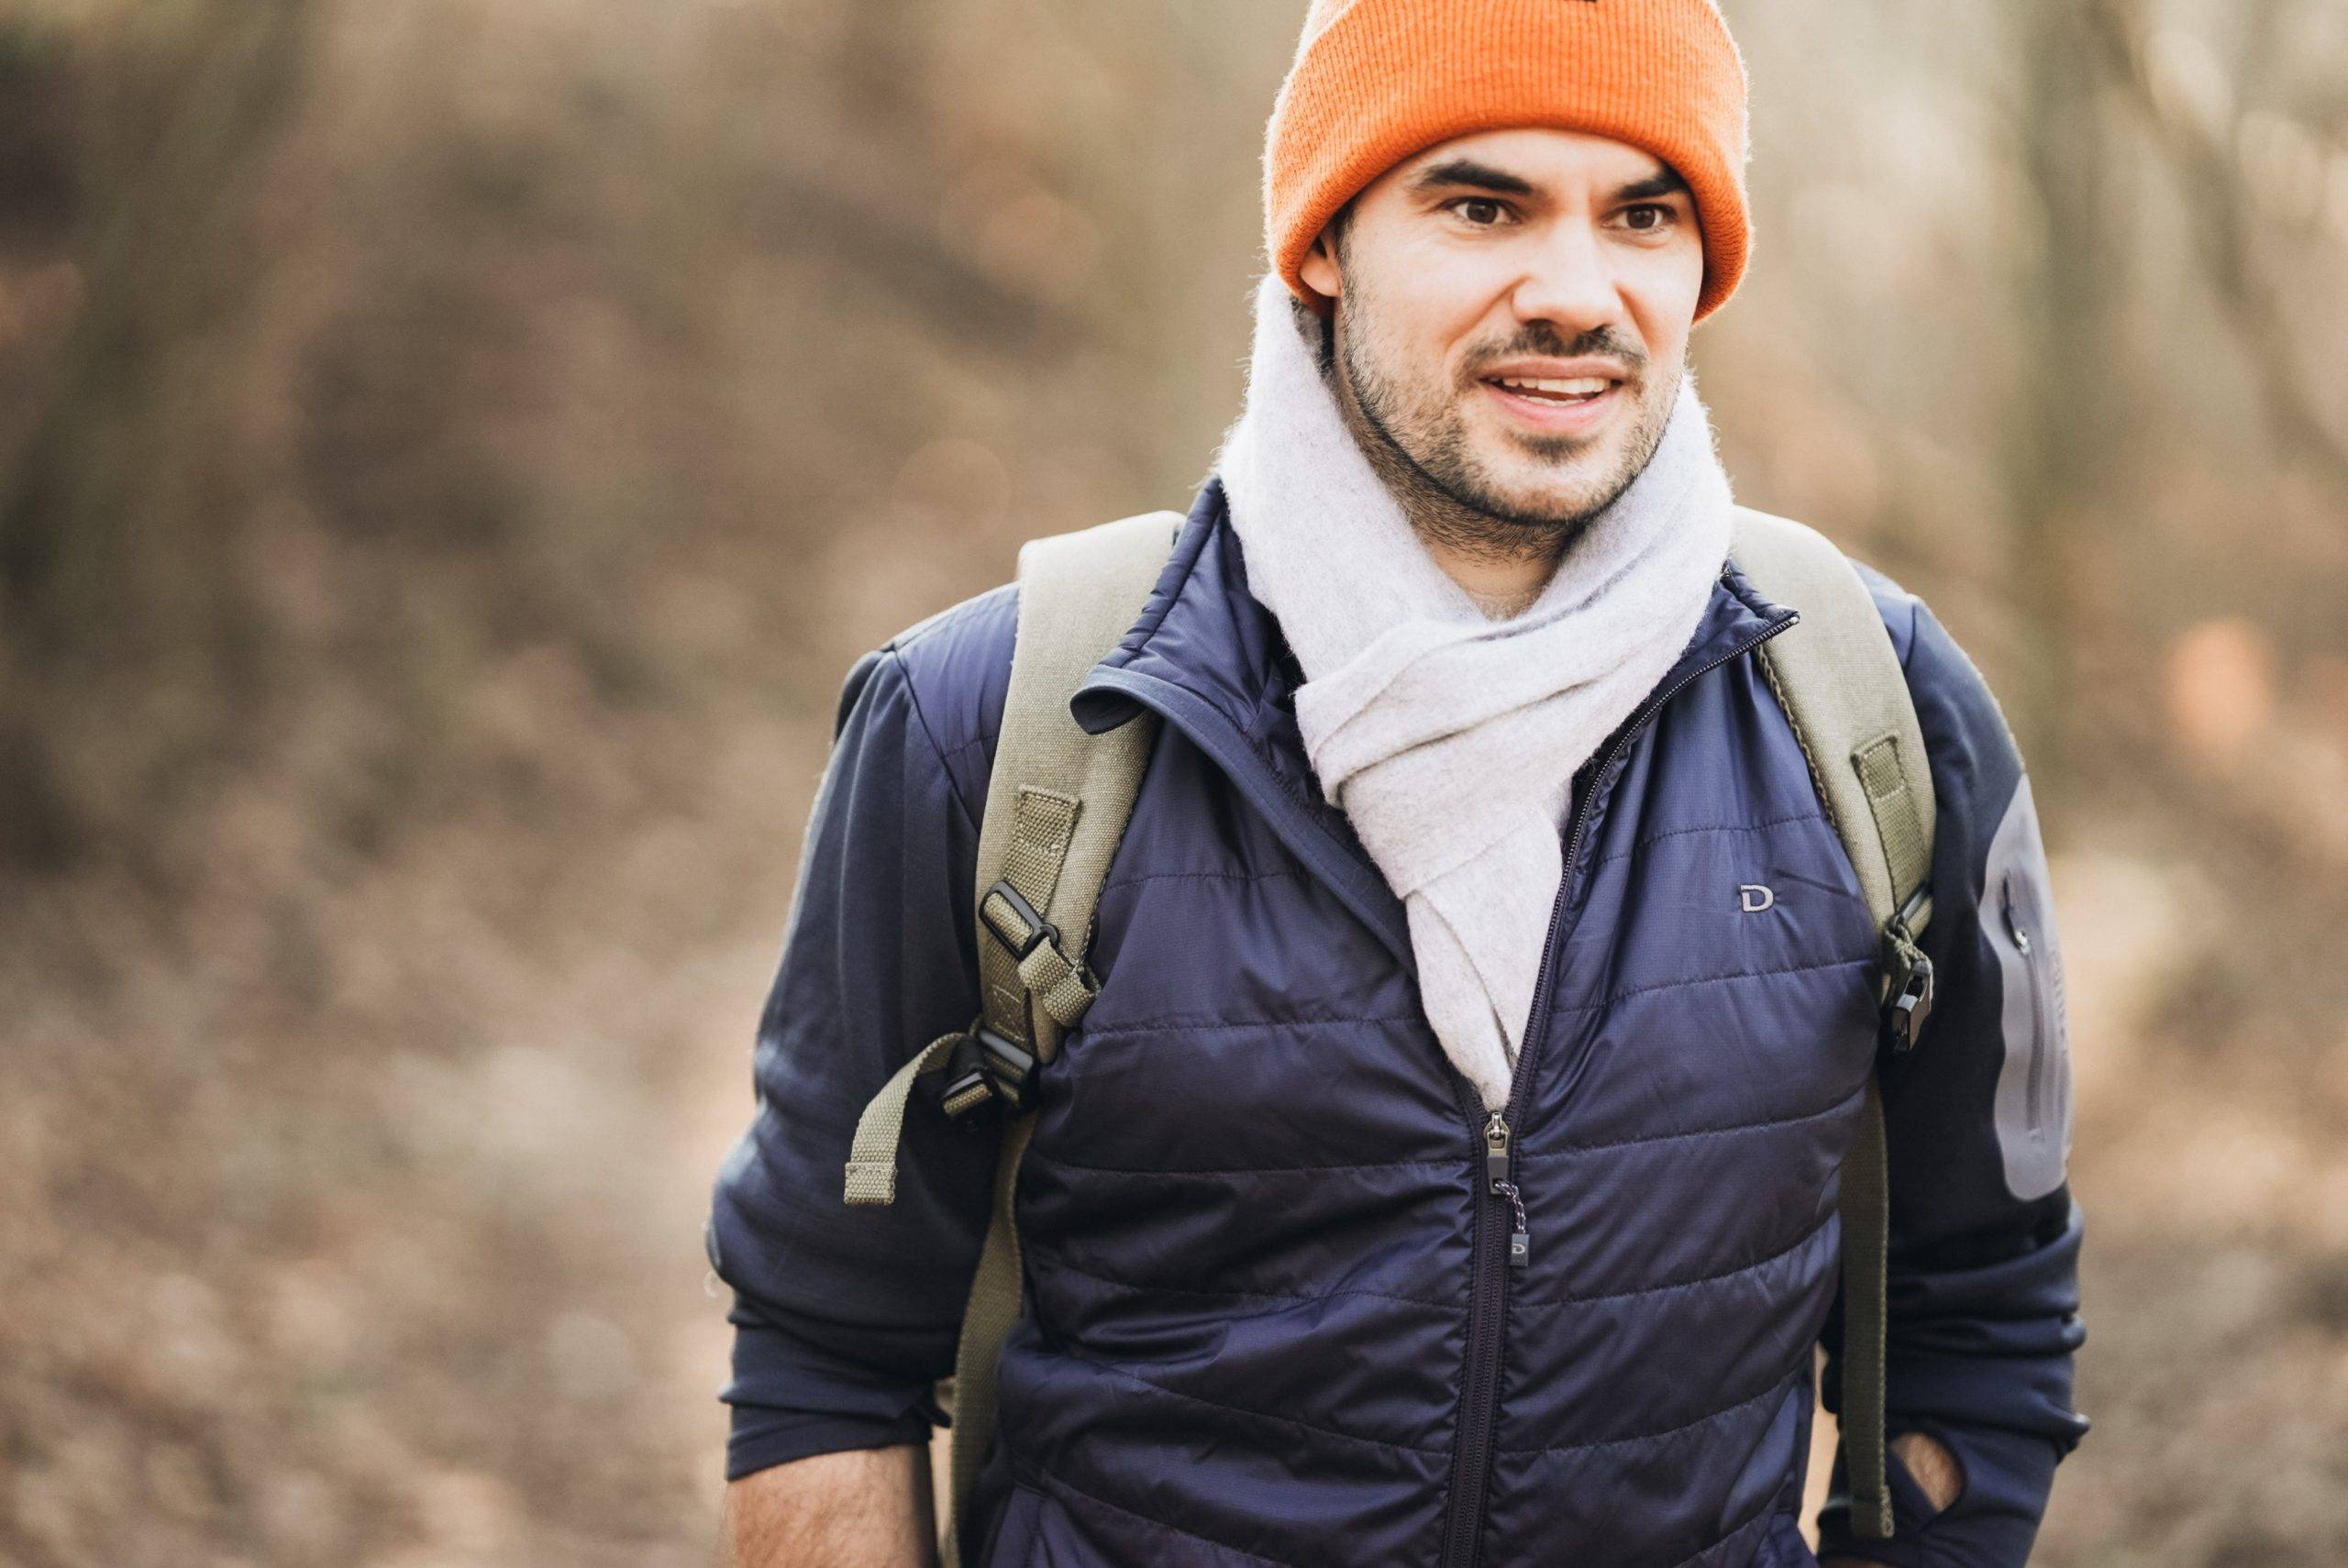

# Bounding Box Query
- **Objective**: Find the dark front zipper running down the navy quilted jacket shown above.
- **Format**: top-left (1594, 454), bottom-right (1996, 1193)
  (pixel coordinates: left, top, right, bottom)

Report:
top-left (1444, 611), bottom-right (1801, 1568)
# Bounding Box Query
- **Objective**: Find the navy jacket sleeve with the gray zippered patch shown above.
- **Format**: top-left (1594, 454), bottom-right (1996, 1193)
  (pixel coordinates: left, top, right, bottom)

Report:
top-left (1820, 580), bottom-right (2088, 1568)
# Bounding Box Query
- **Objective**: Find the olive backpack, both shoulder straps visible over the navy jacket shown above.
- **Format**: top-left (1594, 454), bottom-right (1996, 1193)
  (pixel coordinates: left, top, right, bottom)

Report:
top-left (846, 507), bottom-right (1934, 1568)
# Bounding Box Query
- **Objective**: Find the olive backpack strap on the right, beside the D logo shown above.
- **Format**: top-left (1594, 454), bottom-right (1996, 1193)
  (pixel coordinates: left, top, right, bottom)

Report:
top-left (1728, 507), bottom-right (1934, 1540)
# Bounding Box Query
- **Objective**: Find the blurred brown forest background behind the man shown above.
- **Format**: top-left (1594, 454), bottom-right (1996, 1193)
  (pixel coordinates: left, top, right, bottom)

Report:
top-left (0, 0), bottom-right (2348, 1568)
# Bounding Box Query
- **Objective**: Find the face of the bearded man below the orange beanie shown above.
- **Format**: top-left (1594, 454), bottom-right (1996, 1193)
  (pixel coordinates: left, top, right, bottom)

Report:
top-left (1301, 129), bottom-right (1705, 536)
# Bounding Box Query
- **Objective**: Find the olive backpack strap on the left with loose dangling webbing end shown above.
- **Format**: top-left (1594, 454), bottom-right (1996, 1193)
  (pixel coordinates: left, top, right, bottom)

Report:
top-left (846, 512), bottom-right (1183, 1568)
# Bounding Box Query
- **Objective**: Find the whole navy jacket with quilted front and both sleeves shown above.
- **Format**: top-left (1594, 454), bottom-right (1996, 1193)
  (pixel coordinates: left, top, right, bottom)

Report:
top-left (709, 481), bottom-right (2088, 1568)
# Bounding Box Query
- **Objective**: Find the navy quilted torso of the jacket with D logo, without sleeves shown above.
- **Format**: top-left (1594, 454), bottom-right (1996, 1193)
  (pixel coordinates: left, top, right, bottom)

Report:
top-left (989, 479), bottom-right (1874, 1568)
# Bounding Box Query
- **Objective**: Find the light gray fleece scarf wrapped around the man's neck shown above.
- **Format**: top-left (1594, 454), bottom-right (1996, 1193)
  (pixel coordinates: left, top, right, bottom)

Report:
top-left (1216, 275), bottom-right (1733, 1110)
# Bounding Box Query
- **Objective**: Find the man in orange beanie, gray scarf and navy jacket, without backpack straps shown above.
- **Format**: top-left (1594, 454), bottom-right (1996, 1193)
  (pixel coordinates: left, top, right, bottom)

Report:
top-left (709, 0), bottom-right (2088, 1568)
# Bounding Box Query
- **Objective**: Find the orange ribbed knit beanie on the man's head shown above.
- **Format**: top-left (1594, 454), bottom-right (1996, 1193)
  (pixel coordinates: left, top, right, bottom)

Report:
top-left (1263, 0), bottom-right (1752, 322)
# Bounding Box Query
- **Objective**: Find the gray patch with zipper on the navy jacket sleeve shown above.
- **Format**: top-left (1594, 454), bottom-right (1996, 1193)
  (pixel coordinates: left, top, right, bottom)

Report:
top-left (1982, 772), bottom-right (2071, 1199)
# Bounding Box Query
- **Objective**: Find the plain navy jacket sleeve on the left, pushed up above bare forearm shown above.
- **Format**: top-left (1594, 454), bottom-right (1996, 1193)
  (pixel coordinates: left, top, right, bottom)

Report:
top-left (704, 643), bottom-right (995, 1479)
